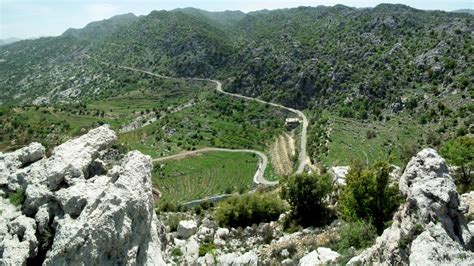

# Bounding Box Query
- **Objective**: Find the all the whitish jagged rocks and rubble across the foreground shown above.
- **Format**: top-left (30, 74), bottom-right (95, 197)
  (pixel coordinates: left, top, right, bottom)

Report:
top-left (0, 126), bottom-right (474, 265)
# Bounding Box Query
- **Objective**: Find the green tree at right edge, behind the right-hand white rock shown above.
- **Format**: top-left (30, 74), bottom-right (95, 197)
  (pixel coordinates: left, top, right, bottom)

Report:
top-left (440, 136), bottom-right (474, 193)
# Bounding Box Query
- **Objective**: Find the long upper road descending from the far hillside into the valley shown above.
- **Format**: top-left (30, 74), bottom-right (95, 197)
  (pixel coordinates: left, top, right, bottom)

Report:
top-left (119, 66), bottom-right (311, 174)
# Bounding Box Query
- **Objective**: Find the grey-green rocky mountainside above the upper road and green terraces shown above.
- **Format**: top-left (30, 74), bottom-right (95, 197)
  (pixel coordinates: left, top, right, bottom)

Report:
top-left (0, 4), bottom-right (474, 111)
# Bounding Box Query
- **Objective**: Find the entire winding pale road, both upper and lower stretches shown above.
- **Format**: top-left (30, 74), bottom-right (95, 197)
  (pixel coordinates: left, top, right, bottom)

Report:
top-left (118, 66), bottom-right (311, 185)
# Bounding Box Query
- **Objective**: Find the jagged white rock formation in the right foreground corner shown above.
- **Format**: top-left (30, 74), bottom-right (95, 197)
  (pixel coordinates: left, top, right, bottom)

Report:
top-left (349, 149), bottom-right (474, 265)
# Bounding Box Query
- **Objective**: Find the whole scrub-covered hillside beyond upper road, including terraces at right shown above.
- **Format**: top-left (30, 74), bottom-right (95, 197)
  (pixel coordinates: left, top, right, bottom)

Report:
top-left (0, 4), bottom-right (474, 163)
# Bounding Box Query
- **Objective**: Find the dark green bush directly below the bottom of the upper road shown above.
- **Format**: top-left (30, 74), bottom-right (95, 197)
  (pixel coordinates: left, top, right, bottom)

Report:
top-left (281, 174), bottom-right (332, 225)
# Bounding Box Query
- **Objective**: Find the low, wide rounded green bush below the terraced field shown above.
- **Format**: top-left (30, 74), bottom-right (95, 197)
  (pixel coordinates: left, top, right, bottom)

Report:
top-left (214, 192), bottom-right (287, 227)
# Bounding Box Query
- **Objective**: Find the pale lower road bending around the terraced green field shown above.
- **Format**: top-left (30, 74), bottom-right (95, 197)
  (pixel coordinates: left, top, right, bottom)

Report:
top-left (153, 148), bottom-right (278, 186)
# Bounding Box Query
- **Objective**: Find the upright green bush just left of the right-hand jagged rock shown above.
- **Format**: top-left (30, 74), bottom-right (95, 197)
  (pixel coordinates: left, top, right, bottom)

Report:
top-left (339, 162), bottom-right (401, 234)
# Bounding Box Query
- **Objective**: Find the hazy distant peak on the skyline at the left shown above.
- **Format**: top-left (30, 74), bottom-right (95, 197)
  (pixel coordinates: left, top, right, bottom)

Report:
top-left (63, 13), bottom-right (138, 40)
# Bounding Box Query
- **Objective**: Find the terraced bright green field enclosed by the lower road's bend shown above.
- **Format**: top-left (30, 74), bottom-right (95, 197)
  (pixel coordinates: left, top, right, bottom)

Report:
top-left (153, 152), bottom-right (258, 205)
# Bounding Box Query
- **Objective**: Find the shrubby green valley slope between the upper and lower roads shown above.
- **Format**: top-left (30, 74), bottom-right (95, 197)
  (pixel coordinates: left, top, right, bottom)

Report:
top-left (0, 74), bottom-right (287, 158)
